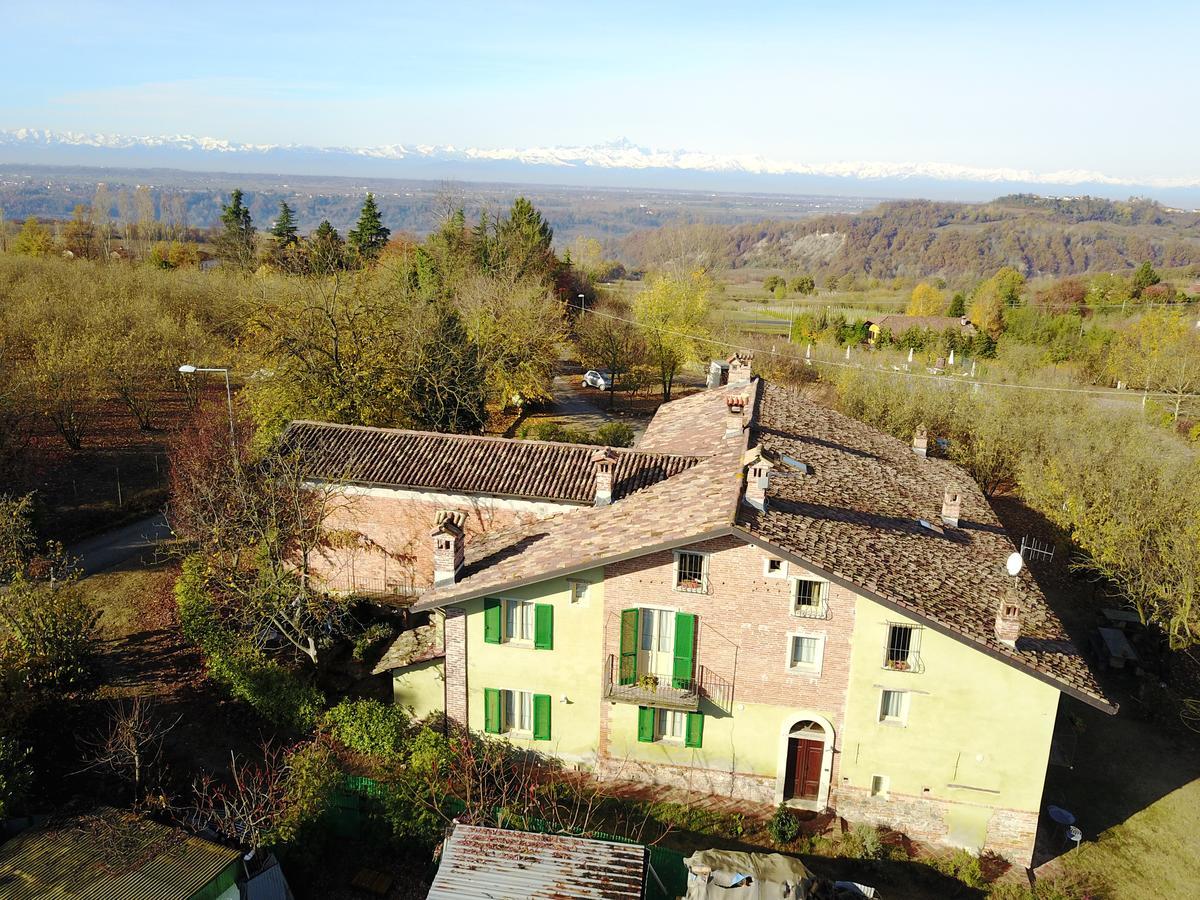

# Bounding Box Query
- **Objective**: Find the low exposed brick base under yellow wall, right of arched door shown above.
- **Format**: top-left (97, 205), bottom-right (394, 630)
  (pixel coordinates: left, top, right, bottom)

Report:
top-left (838, 785), bottom-right (1038, 866)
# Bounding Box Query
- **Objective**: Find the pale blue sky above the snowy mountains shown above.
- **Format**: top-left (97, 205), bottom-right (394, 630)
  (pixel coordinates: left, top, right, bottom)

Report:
top-left (0, 0), bottom-right (1200, 179)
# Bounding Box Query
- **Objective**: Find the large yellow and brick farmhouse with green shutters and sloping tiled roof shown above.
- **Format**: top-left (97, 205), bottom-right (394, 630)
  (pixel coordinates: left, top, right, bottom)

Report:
top-left (295, 357), bottom-right (1115, 864)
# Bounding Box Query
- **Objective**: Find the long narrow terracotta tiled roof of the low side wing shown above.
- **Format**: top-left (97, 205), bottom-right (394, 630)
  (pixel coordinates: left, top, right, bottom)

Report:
top-left (286, 420), bottom-right (696, 504)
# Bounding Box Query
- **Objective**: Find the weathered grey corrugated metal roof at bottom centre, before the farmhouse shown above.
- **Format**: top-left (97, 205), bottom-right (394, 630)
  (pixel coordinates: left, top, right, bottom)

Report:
top-left (428, 824), bottom-right (646, 900)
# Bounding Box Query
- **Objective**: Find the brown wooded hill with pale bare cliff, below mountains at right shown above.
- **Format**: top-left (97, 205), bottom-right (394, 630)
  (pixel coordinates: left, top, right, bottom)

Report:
top-left (620, 194), bottom-right (1200, 280)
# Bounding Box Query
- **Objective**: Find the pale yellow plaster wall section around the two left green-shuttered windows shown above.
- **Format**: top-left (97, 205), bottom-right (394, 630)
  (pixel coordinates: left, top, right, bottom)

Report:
top-left (463, 569), bottom-right (604, 764)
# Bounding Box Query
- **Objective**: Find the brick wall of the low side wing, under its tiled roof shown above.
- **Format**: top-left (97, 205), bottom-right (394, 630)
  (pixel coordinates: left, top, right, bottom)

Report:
top-left (310, 488), bottom-right (576, 592)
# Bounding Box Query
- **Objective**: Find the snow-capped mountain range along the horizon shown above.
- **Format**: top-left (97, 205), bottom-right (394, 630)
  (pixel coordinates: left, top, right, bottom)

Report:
top-left (0, 128), bottom-right (1200, 202)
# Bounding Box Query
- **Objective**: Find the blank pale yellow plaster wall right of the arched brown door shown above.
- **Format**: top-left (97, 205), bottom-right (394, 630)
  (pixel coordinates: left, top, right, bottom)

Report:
top-left (839, 598), bottom-right (1058, 811)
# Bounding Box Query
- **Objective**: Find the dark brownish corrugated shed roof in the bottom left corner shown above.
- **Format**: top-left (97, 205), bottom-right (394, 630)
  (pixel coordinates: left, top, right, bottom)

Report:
top-left (0, 809), bottom-right (239, 900)
